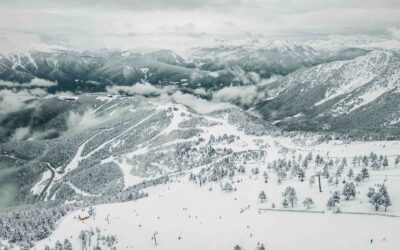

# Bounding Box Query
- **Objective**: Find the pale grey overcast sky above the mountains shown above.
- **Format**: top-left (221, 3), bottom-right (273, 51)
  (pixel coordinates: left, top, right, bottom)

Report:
top-left (0, 0), bottom-right (400, 50)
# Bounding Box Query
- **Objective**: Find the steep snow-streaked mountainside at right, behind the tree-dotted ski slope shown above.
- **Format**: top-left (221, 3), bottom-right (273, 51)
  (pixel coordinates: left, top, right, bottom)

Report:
top-left (258, 50), bottom-right (400, 138)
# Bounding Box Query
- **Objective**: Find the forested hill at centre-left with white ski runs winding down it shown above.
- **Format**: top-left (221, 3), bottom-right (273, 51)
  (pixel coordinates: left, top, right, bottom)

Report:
top-left (0, 95), bottom-right (274, 208)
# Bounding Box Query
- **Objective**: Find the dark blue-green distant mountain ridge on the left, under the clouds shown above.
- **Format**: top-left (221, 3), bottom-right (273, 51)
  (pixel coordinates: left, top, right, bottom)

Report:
top-left (0, 50), bottom-right (216, 92)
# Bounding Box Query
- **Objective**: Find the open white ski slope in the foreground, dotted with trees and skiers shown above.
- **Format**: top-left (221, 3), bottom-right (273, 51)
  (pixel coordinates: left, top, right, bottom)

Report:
top-left (34, 142), bottom-right (400, 250)
